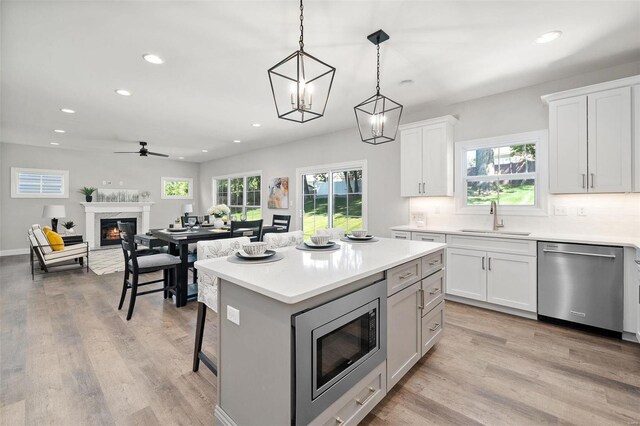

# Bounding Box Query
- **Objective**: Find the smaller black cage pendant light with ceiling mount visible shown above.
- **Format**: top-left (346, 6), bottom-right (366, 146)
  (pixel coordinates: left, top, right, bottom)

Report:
top-left (353, 30), bottom-right (402, 145)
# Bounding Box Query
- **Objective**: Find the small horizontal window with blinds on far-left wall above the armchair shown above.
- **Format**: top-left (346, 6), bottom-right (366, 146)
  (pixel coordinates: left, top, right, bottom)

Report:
top-left (11, 167), bottom-right (69, 198)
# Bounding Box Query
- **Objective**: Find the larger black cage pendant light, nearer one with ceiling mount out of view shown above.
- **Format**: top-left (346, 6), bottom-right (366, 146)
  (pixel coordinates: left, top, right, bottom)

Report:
top-left (268, 0), bottom-right (336, 123)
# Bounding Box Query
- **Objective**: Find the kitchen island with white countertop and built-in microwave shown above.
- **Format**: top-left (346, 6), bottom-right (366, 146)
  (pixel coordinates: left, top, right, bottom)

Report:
top-left (196, 238), bottom-right (445, 425)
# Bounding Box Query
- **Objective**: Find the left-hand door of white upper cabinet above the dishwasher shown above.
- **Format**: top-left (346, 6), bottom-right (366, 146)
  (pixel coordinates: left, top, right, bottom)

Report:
top-left (549, 96), bottom-right (587, 194)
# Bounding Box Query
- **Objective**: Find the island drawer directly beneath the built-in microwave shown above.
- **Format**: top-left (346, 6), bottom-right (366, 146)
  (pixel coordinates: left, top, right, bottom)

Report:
top-left (311, 363), bottom-right (386, 426)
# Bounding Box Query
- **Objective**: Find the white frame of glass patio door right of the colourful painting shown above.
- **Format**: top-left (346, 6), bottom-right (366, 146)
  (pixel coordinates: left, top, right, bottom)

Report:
top-left (295, 160), bottom-right (369, 232)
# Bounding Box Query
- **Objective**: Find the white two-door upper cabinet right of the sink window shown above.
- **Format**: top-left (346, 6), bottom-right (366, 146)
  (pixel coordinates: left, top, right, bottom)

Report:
top-left (542, 76), bottom-right (640, 194)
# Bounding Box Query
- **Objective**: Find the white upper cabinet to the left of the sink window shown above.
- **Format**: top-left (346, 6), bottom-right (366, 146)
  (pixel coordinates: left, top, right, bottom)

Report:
top-left (400, 115), bottom-right (458, 197)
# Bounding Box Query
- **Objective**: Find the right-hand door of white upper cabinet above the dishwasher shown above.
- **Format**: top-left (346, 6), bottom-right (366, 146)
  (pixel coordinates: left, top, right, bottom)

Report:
top-left (588, 87), bottom-right (631, 192)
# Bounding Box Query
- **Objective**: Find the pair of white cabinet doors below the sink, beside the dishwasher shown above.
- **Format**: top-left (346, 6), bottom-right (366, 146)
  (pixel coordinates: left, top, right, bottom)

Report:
top-left (446, 248), bottom-right (537, 312)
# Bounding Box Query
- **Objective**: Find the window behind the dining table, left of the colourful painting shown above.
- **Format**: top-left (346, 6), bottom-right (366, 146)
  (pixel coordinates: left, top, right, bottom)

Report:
top-left (213, 172), bottom-right (262, 220)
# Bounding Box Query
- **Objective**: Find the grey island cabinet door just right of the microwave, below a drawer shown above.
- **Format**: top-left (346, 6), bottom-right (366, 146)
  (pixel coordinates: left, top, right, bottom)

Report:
top-left (387, 282), bottom-right (422, 390)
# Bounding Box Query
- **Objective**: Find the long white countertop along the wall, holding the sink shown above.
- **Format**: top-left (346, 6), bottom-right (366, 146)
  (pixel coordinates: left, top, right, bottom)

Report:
top-left (391, 225), bottom-right (640, 249)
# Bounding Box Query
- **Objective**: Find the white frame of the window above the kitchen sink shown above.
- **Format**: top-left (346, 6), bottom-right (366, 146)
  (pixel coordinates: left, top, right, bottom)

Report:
top-left (454, 129), bottom-right (549, 216)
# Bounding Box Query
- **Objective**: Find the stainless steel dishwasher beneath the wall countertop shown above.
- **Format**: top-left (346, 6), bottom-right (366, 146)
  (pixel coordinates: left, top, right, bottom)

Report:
top-left (538, 241), bottom-right (624, 333)
